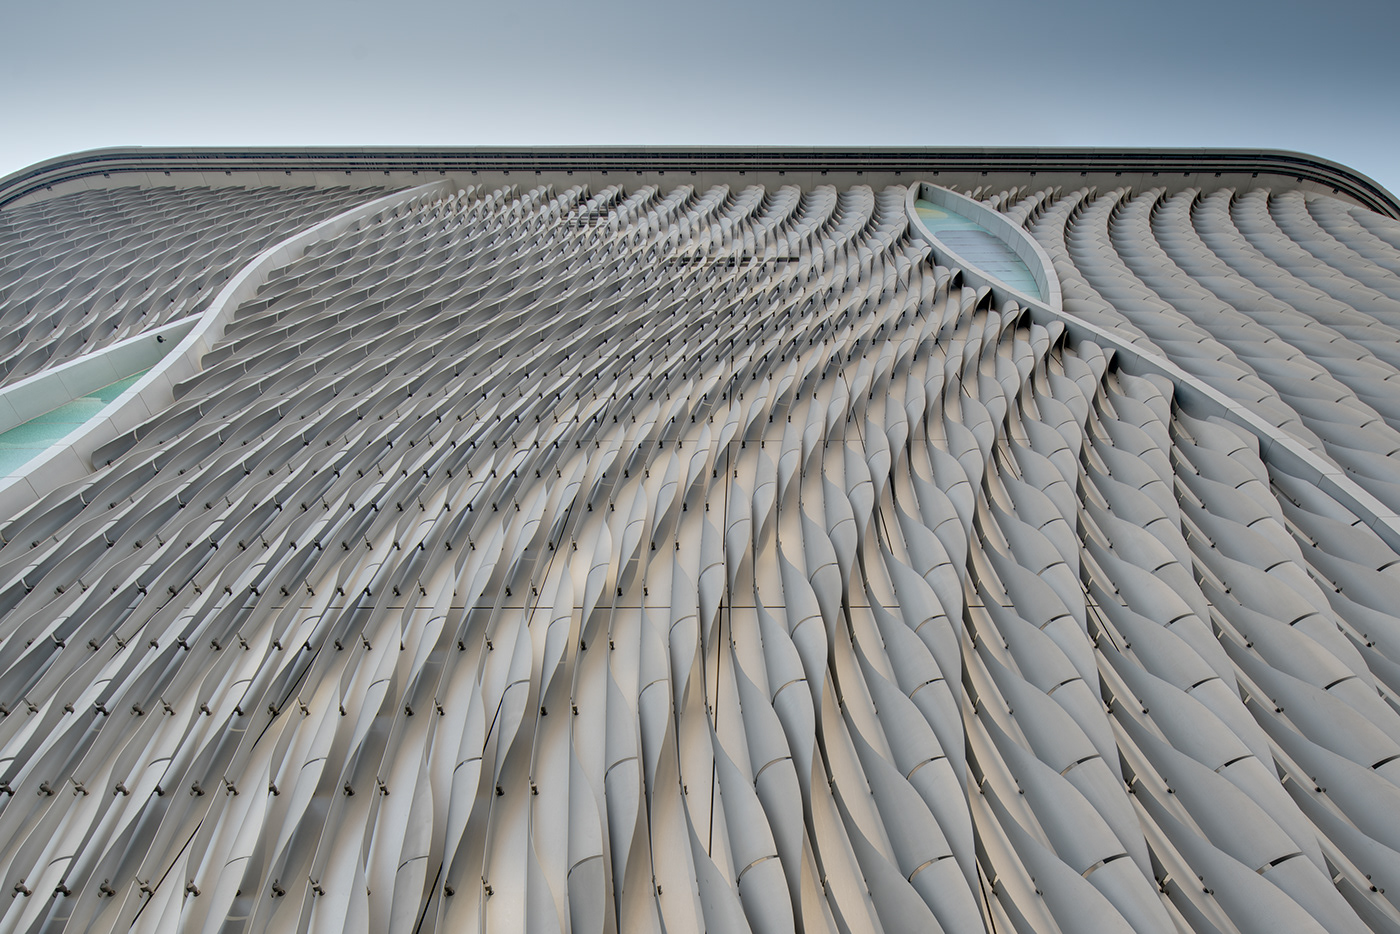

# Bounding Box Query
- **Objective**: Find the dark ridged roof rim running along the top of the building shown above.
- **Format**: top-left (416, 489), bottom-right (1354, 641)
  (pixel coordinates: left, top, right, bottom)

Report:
top-left (0, 146), bottom-right (1400, 218)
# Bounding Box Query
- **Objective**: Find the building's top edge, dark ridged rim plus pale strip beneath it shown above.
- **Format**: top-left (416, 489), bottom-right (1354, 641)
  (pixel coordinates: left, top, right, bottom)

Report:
top-left (0, 146), bottom-right (1400, 218)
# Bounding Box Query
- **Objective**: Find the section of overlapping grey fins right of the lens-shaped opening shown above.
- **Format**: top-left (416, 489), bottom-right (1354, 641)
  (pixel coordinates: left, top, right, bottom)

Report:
top-left (1028, 189), bottom-right (1400, 511)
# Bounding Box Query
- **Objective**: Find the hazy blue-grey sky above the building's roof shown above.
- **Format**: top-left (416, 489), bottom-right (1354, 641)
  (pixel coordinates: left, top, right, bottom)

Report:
top-left (0, 0), bottom-right (1400, 192)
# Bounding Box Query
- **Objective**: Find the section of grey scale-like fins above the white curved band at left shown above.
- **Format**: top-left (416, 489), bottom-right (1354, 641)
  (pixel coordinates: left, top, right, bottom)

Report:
top-left (0, 188), bottom-right (372, 382)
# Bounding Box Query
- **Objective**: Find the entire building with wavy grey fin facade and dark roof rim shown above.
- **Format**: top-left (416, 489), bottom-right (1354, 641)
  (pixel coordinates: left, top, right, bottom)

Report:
top-left (0, 151), bottom-right (1400, 934)
